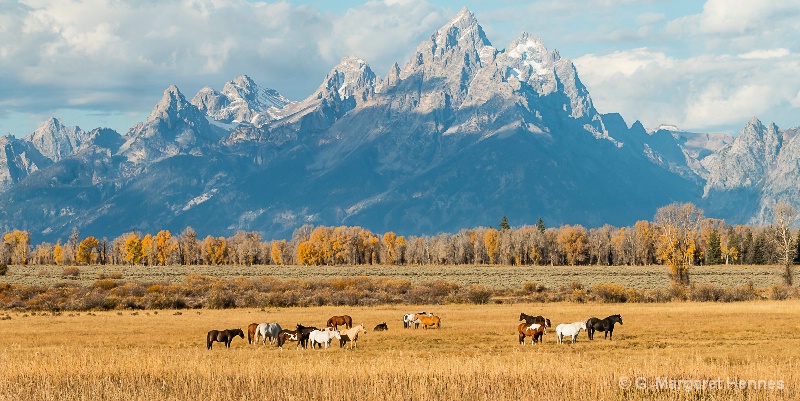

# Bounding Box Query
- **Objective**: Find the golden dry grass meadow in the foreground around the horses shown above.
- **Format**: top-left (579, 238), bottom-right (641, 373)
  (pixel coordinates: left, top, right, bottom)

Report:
top-left (0, 301), bottom-right (800, 401)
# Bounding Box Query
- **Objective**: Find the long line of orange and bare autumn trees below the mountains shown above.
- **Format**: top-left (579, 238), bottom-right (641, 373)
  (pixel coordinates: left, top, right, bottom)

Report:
top-left (0, 203), bottom-right (800, 281)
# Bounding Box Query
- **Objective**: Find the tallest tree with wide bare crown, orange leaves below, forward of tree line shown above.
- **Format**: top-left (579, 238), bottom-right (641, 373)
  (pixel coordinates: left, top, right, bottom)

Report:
top-left (655, 203), bottom-right (703, 285)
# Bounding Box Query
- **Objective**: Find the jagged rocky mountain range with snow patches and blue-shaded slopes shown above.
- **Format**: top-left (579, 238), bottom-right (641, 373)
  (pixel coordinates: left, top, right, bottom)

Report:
top-left (0, 8), bottom-right (800, 241)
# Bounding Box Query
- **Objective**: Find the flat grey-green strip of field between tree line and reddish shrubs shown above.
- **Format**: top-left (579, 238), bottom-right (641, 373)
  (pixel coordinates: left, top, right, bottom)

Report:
top-left (2, 265), bottom-right (781, 290)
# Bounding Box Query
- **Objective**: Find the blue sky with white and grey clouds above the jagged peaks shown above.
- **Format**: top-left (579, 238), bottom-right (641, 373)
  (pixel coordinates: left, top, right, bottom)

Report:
top-left (0, 0), bottom-right (800, 137)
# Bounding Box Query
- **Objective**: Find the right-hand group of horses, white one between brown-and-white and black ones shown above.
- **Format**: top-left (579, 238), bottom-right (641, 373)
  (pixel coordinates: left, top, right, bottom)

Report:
top-left (517, 313), bottom-right (622, 345)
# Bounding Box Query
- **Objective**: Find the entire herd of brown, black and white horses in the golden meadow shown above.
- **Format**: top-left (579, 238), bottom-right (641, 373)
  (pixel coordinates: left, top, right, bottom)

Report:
top-left (206, 312), bottom-right (622, 350)
